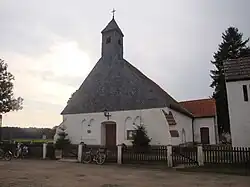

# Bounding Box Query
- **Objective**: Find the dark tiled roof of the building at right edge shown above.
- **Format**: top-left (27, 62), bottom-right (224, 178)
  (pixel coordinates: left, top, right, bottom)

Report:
top-left (224, 57), bottom-right (250, 82)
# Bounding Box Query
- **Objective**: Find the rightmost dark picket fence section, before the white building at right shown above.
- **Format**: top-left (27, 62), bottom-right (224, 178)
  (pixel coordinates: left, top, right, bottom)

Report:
top-left (203, 146), bottom-right (250, 168)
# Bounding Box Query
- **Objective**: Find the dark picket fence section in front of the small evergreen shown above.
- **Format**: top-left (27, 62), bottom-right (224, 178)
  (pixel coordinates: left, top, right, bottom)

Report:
top-left (122, 146), bottom-right (167, 164)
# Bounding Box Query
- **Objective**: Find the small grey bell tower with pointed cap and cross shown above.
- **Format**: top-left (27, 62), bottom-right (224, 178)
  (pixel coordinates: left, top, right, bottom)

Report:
top-left (99, 10), bottom-right (124, 60)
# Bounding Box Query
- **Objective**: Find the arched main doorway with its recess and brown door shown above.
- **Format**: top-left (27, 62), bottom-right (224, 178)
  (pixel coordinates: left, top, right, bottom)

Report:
top-left (101, 121), bottom-right (116, 147)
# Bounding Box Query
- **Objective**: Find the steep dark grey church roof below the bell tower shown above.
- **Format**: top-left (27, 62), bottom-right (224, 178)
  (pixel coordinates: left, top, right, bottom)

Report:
top-left (62, 58), bottom-right (192, 117)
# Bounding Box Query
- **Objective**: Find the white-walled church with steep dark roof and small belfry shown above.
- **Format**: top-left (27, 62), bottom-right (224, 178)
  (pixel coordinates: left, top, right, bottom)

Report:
top-left (55, 18), bottom-right (218, 147)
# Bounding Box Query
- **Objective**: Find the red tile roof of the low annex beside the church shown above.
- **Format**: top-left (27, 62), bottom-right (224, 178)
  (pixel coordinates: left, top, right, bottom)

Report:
top-left (180, 99), bottom-right (216, 117)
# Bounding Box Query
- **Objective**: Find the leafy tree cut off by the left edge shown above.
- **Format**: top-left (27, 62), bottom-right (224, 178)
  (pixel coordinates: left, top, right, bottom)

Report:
top-left (0, 59), bottom-right (23, 140)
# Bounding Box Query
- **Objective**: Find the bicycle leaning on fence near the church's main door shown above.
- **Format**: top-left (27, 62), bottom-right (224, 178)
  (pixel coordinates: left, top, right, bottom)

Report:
top-left (82, 148), bottom-right (107, 165)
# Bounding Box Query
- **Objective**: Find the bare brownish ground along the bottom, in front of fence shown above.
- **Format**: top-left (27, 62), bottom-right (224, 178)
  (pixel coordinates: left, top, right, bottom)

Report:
top-left (0, 160), bottom-right (250, 187)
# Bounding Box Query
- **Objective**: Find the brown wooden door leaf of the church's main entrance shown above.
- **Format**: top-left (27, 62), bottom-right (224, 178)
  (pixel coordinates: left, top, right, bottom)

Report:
top-left (106, 123), bottom-right (116, 147)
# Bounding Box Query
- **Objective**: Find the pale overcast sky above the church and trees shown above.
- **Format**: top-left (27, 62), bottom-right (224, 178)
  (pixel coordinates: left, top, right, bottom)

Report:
top-left (0, 0), bottom-right (250, 127)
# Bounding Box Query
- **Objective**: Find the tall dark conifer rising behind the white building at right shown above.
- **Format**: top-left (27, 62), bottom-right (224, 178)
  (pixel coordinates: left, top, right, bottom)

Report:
top-left (210, 27), bottom-right (249, 134)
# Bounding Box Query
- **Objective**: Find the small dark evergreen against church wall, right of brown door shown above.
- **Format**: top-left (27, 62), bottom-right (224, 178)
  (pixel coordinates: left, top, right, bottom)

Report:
top-left (132, 125), bottom-right (151, 151)
